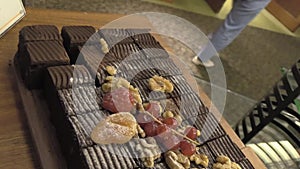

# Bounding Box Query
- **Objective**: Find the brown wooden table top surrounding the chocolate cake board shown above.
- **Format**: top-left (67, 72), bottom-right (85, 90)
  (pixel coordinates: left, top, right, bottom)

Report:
top-left (0, 9), bottom-right (264, 169)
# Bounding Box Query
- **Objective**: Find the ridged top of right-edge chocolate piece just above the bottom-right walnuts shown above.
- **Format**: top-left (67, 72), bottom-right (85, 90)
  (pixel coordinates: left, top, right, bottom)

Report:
top-left (207, 135), bottom-right (245, 162)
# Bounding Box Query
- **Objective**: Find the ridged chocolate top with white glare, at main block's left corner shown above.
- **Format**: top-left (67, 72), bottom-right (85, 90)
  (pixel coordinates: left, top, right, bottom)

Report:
top-left (47, 65), bottom-right (94, 90)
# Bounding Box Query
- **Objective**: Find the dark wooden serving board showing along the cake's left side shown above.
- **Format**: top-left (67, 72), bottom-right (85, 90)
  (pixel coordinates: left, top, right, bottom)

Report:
top-left (12, 60), bottom-right (67, 169)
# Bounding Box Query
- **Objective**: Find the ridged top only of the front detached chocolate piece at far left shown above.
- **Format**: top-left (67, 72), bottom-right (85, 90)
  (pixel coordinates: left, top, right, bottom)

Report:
top-left (25, 41), bottom-right (70, 66)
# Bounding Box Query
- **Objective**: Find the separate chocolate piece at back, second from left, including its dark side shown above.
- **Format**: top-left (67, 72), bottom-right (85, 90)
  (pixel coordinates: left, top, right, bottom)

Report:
top-left (61, 26), bottom-right (99, 64)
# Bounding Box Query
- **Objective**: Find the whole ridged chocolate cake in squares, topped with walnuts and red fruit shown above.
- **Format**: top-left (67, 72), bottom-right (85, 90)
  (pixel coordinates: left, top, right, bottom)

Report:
top-left (15, 25), bottom-right (253, 169)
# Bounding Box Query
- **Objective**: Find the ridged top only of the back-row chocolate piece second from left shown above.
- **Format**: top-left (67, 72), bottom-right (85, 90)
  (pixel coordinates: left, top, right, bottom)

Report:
top-left (61, 26), bottom-right (96, 45)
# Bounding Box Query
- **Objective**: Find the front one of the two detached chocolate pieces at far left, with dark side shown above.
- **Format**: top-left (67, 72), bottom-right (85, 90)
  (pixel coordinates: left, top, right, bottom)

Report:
top-left (19, 41), bottom-right (70, 89)
